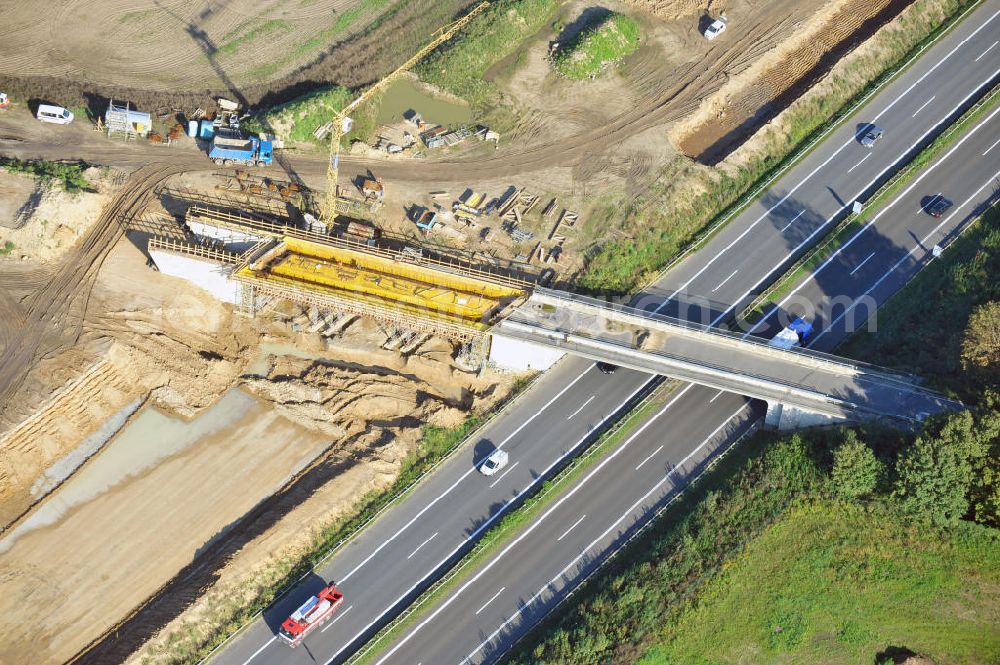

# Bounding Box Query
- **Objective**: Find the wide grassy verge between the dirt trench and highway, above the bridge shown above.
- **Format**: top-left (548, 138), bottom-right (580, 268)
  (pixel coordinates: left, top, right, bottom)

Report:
top-left (578, 0), bottom-right (981, 293)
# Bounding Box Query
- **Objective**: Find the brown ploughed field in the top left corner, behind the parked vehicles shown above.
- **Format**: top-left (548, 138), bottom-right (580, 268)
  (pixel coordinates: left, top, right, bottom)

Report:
top-left (0, 0), bottom-right (480, 113)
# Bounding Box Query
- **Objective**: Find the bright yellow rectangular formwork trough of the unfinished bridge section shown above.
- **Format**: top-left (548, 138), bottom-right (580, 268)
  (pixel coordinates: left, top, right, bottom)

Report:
top-left (239, 236), bottom-right (526, 329)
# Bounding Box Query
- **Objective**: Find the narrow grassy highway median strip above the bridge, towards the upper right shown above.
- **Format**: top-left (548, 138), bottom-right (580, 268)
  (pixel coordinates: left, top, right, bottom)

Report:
top-left (738, 86), bottom-right (1000, 323)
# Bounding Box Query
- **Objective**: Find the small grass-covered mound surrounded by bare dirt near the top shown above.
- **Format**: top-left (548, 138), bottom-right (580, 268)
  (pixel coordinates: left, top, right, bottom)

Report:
top-left (552, 12), bottom-right (639, 80)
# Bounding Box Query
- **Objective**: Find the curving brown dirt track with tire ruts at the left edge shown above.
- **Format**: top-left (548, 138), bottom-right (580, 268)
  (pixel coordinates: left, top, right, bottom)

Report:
top-left (0, 164), bottom-right (180, 421)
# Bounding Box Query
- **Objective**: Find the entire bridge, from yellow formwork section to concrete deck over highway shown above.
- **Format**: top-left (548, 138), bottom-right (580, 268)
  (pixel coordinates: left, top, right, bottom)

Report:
top-left (149, 206), bottom-right (961, 427)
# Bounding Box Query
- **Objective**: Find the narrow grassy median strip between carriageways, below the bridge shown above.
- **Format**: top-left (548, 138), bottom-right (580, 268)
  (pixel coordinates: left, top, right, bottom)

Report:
top-left (347, 382), bottom-right (680, 665)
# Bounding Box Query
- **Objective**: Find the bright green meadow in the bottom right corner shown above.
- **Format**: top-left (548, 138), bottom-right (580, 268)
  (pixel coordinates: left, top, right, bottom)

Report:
top-left (639, 501), bottom-right (1000, 665)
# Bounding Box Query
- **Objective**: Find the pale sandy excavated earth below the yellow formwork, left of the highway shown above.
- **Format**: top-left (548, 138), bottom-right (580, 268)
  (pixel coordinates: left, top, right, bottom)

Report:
top-left (0, 205), bottom-right (510, 663)
